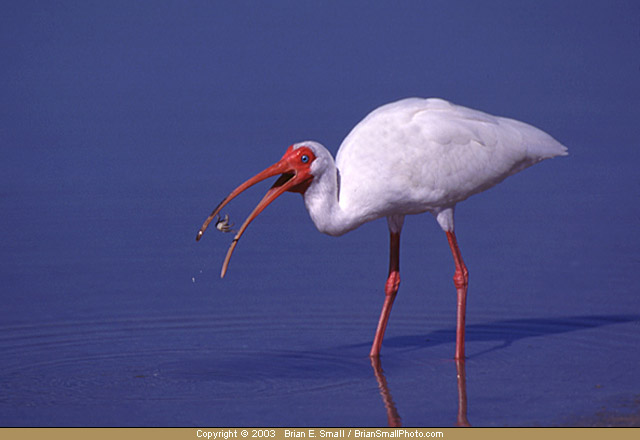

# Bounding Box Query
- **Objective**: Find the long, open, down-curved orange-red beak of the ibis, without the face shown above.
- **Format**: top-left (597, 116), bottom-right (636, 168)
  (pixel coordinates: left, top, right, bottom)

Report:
top-left (196, 148), bottom-right (313, 278)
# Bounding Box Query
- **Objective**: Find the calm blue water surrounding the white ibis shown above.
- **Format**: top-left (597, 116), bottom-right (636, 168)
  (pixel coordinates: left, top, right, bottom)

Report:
top-left (0, 1), bottom-right (640, 426)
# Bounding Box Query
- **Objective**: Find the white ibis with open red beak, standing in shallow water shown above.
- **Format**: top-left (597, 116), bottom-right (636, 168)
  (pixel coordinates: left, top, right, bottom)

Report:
top-left (196, 98), bottom-right (567, 359)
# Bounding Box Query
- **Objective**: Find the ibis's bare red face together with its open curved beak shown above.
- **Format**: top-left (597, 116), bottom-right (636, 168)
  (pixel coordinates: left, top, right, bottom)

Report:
top-left (196, 145), bottom-right (316, 278)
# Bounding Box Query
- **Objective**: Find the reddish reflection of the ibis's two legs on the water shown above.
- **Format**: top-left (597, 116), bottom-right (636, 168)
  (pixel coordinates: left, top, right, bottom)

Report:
top-left (371, 356), bottom-right (471, 428)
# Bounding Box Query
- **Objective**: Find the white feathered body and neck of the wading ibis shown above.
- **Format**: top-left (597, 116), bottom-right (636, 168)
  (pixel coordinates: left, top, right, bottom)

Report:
top-left (296, 98), bottom-right (566, 235)
